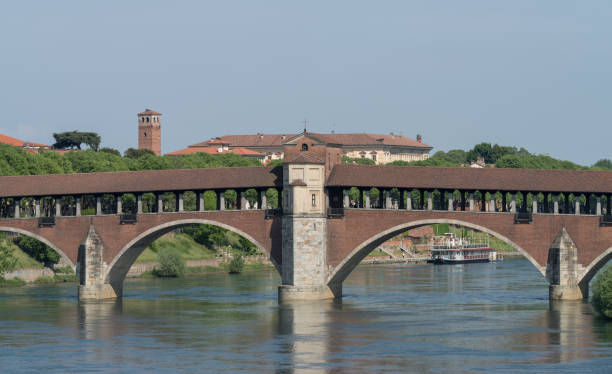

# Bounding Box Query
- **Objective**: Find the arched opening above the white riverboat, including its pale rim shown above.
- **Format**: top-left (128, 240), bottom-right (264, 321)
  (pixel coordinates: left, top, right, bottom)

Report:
top-left (328, 219), bottom-right (548, 292)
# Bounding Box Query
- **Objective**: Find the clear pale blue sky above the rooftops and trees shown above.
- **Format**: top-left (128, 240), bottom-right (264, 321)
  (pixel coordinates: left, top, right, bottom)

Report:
top-left (0, 0), bottom-right (612, 165)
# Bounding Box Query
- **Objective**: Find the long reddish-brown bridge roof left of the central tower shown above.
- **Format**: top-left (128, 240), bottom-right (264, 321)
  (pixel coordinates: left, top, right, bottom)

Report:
top-left (0, 166), bottom-right (282, 197)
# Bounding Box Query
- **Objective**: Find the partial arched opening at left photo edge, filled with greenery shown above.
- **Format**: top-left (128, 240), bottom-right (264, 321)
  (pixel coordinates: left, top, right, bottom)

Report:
top-left (0, 227), bottom-right (76, 281)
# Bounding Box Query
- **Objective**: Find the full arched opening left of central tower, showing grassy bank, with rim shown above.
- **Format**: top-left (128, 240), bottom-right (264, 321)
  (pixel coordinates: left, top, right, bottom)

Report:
top-left (104, 219), bottom-right (278, 295)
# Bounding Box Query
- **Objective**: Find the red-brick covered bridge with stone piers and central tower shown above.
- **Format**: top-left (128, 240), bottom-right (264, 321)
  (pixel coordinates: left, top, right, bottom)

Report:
top-left (0, 160), bottom-right (612, 300)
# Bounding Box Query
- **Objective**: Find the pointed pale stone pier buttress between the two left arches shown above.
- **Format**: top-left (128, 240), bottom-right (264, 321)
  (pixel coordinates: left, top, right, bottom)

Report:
top-left (77, 225), bottom-right (118, 301)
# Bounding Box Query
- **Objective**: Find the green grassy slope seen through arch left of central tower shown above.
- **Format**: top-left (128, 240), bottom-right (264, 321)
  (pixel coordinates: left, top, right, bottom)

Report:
top-left (136, 234), bottom-right (217, 262)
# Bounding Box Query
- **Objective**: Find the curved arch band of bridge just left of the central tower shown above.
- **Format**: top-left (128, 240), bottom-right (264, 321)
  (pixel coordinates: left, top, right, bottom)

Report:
top-left (104, 218), bottom-right (279, 290)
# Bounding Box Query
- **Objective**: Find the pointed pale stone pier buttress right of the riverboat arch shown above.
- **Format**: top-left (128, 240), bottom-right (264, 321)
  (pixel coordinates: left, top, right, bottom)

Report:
top-left (546, 227), bottom-right (589, 300)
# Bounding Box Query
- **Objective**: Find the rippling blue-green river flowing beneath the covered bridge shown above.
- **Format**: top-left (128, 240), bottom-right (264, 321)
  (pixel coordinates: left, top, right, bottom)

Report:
top-left (0, 259), bottom-right (612, 373)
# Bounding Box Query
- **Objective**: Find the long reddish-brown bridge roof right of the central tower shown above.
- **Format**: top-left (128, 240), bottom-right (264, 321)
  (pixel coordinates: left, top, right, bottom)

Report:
top-left (327, 165), bottom-right (612, 193)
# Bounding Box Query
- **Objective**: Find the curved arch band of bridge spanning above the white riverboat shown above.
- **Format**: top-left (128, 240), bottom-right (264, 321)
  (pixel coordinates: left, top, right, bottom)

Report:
top-left (327, 219), bottom-right (546, 285)
